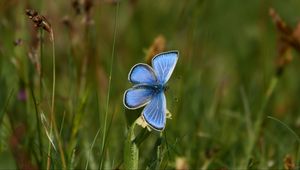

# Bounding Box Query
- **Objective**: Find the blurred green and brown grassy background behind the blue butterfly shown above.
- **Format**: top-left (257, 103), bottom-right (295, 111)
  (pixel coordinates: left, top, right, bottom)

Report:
top-left (0, 0), bottom-right (300, 169)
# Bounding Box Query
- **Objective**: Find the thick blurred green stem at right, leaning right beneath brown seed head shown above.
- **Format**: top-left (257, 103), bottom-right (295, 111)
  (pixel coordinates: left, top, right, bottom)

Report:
top-left (246, 76), bottom-right (279, 167)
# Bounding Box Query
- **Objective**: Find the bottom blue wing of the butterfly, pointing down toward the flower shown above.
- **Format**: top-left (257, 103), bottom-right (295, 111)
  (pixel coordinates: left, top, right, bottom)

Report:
top-left (142, 92), bottom-right (167, 131)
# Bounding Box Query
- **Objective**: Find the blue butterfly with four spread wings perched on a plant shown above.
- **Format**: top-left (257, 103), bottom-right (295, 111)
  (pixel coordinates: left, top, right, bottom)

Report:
top-left (123, 51), bottom-right (179, 131)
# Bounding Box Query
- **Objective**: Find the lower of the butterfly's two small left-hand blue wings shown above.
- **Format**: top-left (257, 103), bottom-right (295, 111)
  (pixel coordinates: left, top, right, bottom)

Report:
top-left (123, 85), bottom-right (155, 109)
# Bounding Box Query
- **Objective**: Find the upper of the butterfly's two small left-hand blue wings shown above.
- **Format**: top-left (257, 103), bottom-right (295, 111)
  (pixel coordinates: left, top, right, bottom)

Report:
top-left (128, 63), bottom-right (157, 84)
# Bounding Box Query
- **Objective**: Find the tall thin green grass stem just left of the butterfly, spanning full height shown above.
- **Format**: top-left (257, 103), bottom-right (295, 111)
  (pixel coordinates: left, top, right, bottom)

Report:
top-left (99, 2), bottom-right (120, 169)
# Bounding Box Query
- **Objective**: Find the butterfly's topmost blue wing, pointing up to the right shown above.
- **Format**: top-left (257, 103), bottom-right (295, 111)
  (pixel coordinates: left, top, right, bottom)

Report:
top-left (152, 51), bottom-right (179, 84)
